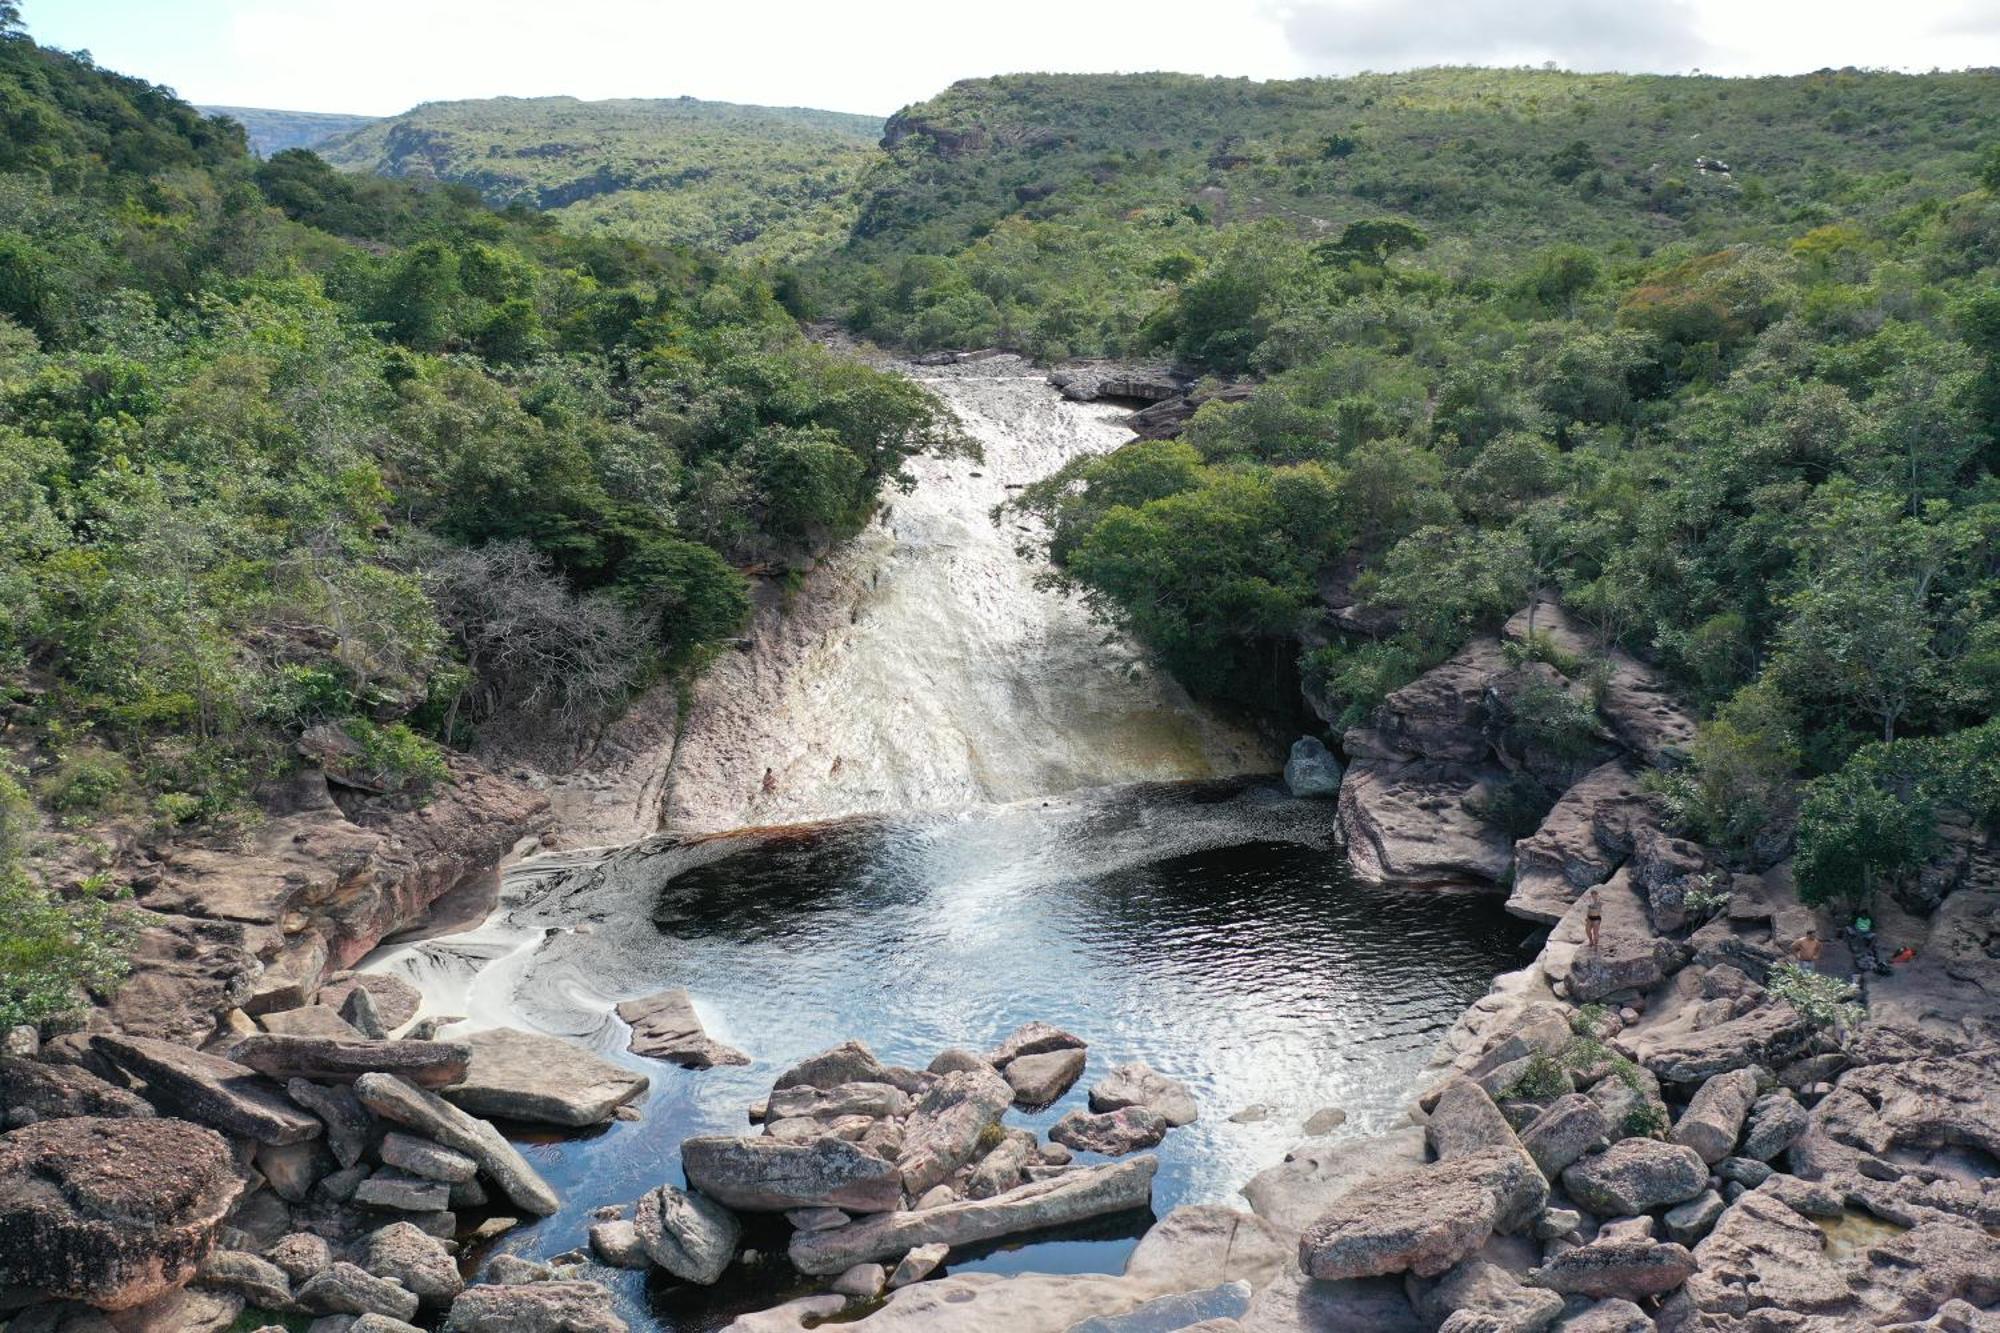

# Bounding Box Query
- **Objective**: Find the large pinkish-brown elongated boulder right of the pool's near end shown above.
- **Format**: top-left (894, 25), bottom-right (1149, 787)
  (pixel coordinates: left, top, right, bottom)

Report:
top-left (1298, 1149), bottom-right (1548, 1279)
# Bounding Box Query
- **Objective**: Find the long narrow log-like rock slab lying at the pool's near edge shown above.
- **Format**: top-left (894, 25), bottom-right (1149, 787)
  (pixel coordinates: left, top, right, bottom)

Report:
top-left (790, 1157), bottom-right (1160, 1275)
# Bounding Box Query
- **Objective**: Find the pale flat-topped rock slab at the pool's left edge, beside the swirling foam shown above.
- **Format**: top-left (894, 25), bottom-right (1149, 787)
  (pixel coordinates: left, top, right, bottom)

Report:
top-left (444, 1027), bottom-right (650, 1129)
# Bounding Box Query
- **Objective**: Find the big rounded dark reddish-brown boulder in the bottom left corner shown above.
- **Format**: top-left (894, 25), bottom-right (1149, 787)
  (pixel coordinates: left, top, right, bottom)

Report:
top-left (0, 1117), bottom-right (242, 1309)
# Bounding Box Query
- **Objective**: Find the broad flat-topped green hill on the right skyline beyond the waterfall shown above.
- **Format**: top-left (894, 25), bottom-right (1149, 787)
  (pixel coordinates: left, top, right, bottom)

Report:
top-left (830, 68), bottom-right (2000, 356)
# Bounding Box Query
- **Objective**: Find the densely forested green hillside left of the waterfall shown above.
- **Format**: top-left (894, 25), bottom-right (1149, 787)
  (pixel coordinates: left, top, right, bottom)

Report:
top-left (0, 6), bottom-right (950, 1023)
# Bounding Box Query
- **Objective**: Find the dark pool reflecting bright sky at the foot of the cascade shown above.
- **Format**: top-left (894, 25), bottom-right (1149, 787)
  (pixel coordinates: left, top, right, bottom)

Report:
top-left (376, 783), bottom-right (1522, 1329)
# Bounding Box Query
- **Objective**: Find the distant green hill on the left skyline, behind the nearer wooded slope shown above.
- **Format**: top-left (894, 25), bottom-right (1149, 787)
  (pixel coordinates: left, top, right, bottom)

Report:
top-left (318, 98), bottom-right (882, 258)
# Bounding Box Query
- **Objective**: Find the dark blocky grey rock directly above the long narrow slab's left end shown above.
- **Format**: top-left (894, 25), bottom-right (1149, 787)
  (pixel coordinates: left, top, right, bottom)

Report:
top-left (680, 1128), bottom-right (908, 1213)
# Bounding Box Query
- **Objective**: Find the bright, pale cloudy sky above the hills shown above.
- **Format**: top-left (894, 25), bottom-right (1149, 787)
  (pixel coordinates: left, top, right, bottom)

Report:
top-left (22, 0), bottom-right (2000, 116)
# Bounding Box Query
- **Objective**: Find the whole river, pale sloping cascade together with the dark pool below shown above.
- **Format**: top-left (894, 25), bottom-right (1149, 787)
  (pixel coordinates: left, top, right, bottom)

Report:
top-left (372, 356), bottom-right (1522, 1333)
